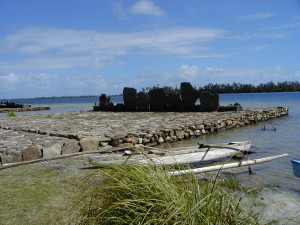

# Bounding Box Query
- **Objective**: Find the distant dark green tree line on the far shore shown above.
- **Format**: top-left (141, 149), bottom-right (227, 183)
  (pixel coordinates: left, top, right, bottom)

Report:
top-left (142, 81), bottom-right (300, 94)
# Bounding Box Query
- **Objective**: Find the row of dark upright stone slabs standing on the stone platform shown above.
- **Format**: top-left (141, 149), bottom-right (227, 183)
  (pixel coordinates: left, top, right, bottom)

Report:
top-left (94, 82), bottom-right (219, 112)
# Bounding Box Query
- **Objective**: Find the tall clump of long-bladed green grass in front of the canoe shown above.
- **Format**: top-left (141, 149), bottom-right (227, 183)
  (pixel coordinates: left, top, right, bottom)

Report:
top-left (81, 164), bottom-right (258, 225)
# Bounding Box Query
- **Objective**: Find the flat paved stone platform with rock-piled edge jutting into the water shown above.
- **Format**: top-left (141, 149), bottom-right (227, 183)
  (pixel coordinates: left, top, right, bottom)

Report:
top-left (0, 107), bottom-right (288, 164)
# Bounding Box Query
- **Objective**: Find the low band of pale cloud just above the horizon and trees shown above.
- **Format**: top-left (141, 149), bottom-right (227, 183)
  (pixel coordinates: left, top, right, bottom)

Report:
top-left (0, 64), bottom-right (300, 98)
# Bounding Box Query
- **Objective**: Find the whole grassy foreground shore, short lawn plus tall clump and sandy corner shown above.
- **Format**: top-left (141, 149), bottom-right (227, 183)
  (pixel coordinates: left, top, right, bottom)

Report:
top-left (0, 156), bottom-right (300, 225)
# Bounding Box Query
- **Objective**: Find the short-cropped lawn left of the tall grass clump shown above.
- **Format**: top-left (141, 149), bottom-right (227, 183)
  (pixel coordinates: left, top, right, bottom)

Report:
top-left (0, 157), bottom-right (90, 225)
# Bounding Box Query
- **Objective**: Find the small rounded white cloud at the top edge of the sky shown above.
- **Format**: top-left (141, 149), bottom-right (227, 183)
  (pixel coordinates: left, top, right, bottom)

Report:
top-left (129, 0), bottom-right (164, 16)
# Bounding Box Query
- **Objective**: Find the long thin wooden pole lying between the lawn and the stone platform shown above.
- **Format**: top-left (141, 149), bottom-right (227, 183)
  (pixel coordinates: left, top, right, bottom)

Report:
top-left (0, 147), bottom-right (132, 169)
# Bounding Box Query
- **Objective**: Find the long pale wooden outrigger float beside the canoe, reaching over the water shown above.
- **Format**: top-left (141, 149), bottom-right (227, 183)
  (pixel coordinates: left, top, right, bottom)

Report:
top-left (169, 153), bottom-right (288, 176)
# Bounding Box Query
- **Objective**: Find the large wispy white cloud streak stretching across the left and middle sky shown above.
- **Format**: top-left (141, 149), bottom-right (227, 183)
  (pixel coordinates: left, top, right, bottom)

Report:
top-left (0, 27), bottom-right (225, 71)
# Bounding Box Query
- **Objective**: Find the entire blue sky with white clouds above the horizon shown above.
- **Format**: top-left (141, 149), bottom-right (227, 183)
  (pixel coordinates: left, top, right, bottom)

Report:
top-left (0, 0), bottom-right (300, 98)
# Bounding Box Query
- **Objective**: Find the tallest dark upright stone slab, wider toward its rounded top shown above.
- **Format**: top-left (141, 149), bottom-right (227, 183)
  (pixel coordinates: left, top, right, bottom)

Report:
top-left (180, 82), bottom-right (199, 112)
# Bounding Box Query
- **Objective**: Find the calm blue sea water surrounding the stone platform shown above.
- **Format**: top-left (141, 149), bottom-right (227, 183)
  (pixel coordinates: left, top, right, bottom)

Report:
top-left (0, 92), bottom-right (300, 194)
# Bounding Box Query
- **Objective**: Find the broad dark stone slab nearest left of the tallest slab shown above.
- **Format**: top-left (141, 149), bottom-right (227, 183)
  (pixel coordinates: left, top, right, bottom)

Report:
top-left (149, 88), bottom-right (168, 112)
